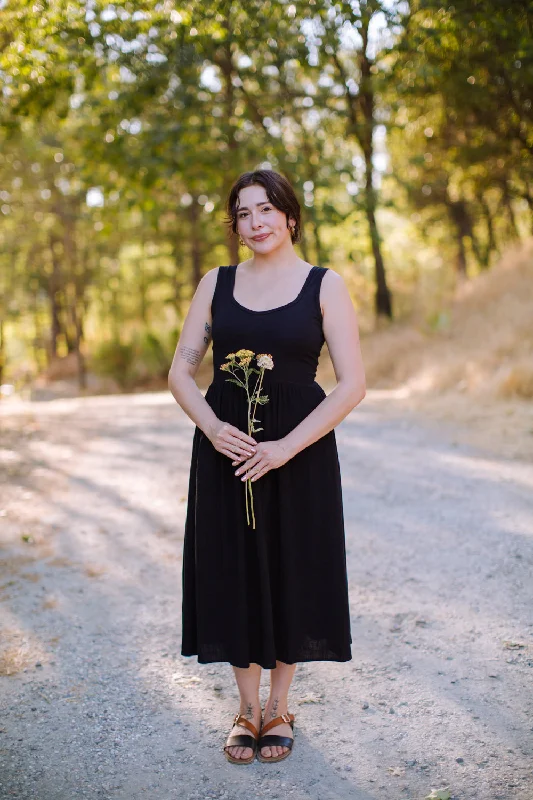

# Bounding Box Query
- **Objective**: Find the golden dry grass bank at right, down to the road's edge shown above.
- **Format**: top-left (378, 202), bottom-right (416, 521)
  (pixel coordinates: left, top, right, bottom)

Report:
top-left (354, 239), bottom-right (533, 460)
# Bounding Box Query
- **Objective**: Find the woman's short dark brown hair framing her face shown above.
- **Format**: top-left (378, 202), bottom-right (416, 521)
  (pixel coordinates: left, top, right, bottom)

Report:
top-left (226, 169), bottom-right (301, 244)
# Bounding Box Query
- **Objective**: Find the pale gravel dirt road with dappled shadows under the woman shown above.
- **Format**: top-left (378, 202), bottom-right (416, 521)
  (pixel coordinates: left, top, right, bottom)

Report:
top-left (0, 392), bottom-right (533, 800)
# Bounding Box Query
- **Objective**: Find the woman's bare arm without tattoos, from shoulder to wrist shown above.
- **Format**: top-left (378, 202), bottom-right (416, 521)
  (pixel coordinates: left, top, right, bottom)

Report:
top-left (279, 270), bottom-right (366, 458)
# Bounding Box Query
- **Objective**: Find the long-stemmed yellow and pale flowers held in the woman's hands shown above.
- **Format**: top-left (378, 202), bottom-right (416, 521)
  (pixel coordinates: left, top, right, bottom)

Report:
top-left (220, 350), bottom-right (274, 529)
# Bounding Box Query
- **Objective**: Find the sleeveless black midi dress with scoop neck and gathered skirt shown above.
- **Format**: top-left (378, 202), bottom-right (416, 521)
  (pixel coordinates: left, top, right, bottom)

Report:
top-left (181, 266), bottom-right (352, 669)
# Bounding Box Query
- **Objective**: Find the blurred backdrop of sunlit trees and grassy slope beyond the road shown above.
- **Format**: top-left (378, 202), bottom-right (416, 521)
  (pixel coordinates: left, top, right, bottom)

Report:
top-left (0, 0), bottom-right (533, 436)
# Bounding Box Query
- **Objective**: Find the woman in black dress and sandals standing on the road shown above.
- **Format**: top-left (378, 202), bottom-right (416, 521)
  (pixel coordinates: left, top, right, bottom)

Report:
top-left (169, 170), bottom-right (365, 764)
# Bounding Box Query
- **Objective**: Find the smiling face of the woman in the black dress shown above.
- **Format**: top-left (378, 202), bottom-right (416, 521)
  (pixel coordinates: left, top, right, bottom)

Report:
top-left (237, 184), bottom-right (295, 253)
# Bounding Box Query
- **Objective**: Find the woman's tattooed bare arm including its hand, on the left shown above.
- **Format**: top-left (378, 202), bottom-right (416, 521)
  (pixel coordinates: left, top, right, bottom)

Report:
top-left (168, 267), bottom-right (257, 458)
